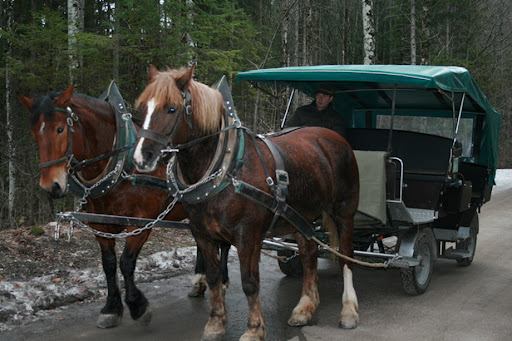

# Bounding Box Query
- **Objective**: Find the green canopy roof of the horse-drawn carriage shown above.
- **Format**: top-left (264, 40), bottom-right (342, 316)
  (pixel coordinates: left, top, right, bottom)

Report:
top-left (237, 65), bottom-right (500, 181)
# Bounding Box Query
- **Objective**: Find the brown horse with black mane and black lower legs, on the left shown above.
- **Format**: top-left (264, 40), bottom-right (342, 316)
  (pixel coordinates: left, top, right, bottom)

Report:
top-left (19, 86), bottom-right (228, 328)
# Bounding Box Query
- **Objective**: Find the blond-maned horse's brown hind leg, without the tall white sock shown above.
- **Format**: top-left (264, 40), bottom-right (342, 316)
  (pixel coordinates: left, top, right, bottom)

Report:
top-left (288, 233), bottom-right (320, 327)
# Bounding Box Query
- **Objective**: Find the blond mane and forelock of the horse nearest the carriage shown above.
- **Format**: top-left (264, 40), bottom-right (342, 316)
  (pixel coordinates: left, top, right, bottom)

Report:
top-left (135, 69), bottom-right (224, 133)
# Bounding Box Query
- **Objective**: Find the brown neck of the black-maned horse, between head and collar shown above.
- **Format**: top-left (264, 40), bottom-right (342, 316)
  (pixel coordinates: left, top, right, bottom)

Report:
top-left (73, 101), bottom-right (116, 178)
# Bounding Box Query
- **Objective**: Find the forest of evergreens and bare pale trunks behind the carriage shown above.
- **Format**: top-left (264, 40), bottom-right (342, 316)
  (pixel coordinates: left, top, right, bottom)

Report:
top-left (0, 0), bottom-right (512, 229)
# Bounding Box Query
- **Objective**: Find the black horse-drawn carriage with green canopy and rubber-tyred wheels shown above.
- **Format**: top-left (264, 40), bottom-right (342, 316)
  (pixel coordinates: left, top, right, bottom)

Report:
top-left (238, 65), bottom-right (500, 294)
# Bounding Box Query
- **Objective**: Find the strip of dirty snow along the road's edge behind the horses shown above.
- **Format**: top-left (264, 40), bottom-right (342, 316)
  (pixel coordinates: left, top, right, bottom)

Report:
top-left (0, 246), bottom-right (196, 332)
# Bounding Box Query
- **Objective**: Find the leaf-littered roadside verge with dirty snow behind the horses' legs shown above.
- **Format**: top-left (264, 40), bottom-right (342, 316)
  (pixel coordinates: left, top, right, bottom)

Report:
top-left (0, 220), bottom-right (196, 332)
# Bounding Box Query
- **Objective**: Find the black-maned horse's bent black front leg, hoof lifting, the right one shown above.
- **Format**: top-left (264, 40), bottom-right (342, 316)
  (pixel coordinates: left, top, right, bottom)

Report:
top-left (120, 230), bottom-right (152, 326)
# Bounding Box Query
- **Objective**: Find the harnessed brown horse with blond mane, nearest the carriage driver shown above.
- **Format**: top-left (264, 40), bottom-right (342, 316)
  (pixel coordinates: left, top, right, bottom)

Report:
top-left (134, 66), bottom-right (359, 340)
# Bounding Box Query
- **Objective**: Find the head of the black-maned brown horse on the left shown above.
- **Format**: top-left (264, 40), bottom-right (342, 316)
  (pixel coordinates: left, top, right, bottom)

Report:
top-left (18, 85), bottom-right (78, 198)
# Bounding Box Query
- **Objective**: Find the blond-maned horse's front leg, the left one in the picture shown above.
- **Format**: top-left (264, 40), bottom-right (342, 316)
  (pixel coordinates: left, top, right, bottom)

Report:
top-left (194, 236), bottom-right (227, 341)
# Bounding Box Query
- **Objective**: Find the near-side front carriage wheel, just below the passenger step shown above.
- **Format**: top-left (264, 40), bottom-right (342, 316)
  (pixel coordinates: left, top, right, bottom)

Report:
top-left (400, 228), bottom-right (436, 295)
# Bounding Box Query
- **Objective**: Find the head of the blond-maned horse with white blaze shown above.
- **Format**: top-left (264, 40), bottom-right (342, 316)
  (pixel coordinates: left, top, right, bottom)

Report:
top-left (133, 66), bottom-right (223, 172)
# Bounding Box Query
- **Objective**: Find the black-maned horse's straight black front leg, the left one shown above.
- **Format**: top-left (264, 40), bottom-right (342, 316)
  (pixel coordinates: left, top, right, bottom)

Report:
top-left (96, 237), bottom-right (123, 328)
